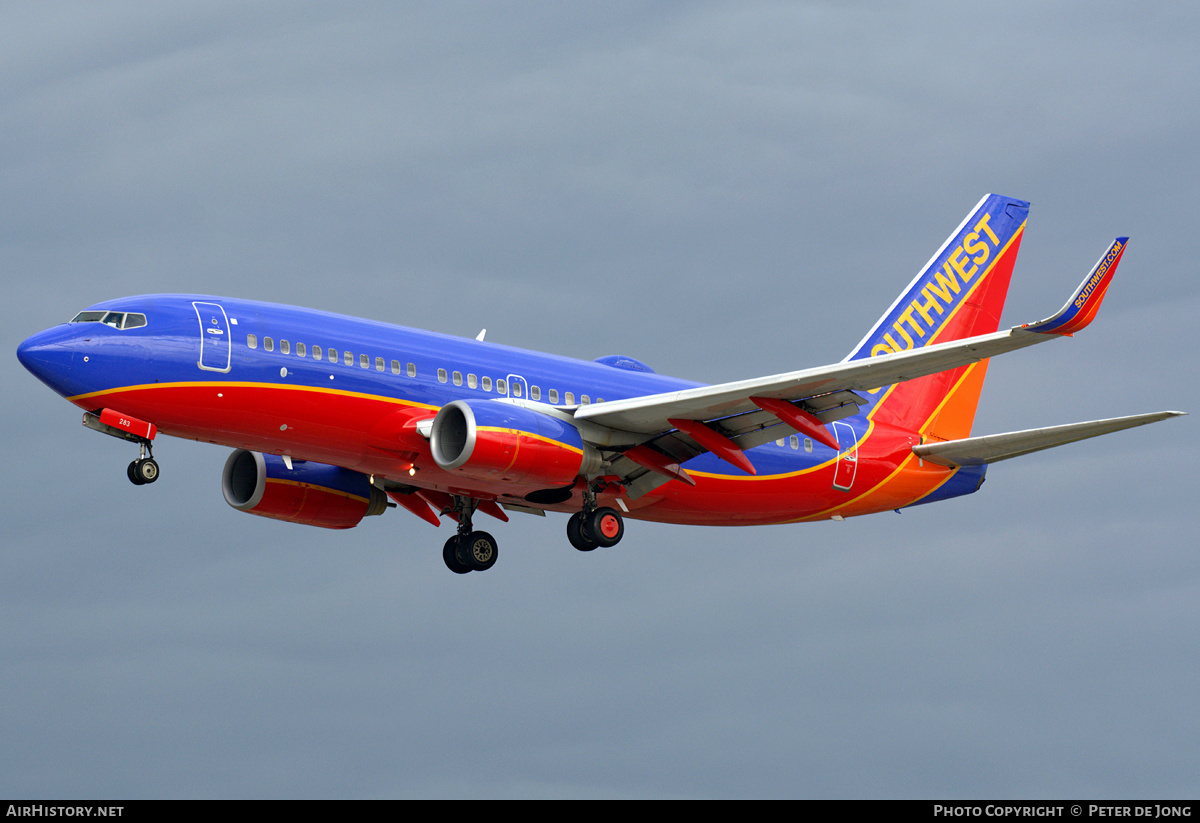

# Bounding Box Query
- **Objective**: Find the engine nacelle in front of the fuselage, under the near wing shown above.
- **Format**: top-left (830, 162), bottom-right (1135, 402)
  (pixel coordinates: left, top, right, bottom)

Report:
top-left (430, 400), bottom-right (601, 488)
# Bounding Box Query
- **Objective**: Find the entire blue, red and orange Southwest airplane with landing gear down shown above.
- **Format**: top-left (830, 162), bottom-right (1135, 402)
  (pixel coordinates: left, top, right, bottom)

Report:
top-left (17, 194), bottom-right (1183, 573)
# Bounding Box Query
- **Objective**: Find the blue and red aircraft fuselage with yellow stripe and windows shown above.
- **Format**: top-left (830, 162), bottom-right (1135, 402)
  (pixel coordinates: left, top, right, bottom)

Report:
top-left (19, 295), bottom-right (983, 525)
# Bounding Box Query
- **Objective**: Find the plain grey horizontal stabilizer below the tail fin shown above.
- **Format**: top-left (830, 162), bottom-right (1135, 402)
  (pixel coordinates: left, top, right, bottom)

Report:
top-left (912, 412), bottom-right (1186, 468)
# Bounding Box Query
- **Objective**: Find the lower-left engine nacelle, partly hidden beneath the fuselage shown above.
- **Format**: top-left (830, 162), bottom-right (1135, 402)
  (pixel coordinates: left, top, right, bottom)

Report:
top-left (221, 449), bottom-right (388, 529)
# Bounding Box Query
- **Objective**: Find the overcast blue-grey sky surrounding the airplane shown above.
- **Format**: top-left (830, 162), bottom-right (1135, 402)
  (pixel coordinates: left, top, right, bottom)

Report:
top-left (0, 2), bottom-right (1200, 798)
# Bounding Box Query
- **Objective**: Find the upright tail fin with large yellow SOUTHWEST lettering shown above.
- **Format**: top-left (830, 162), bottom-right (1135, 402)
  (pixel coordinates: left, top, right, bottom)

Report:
top-left (846, 194), bottom-right (1030, 441)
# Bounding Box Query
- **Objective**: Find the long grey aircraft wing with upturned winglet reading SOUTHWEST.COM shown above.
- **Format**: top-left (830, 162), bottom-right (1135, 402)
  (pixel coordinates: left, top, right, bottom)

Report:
top-left (575, 238), bottom-right (1128, 439)
